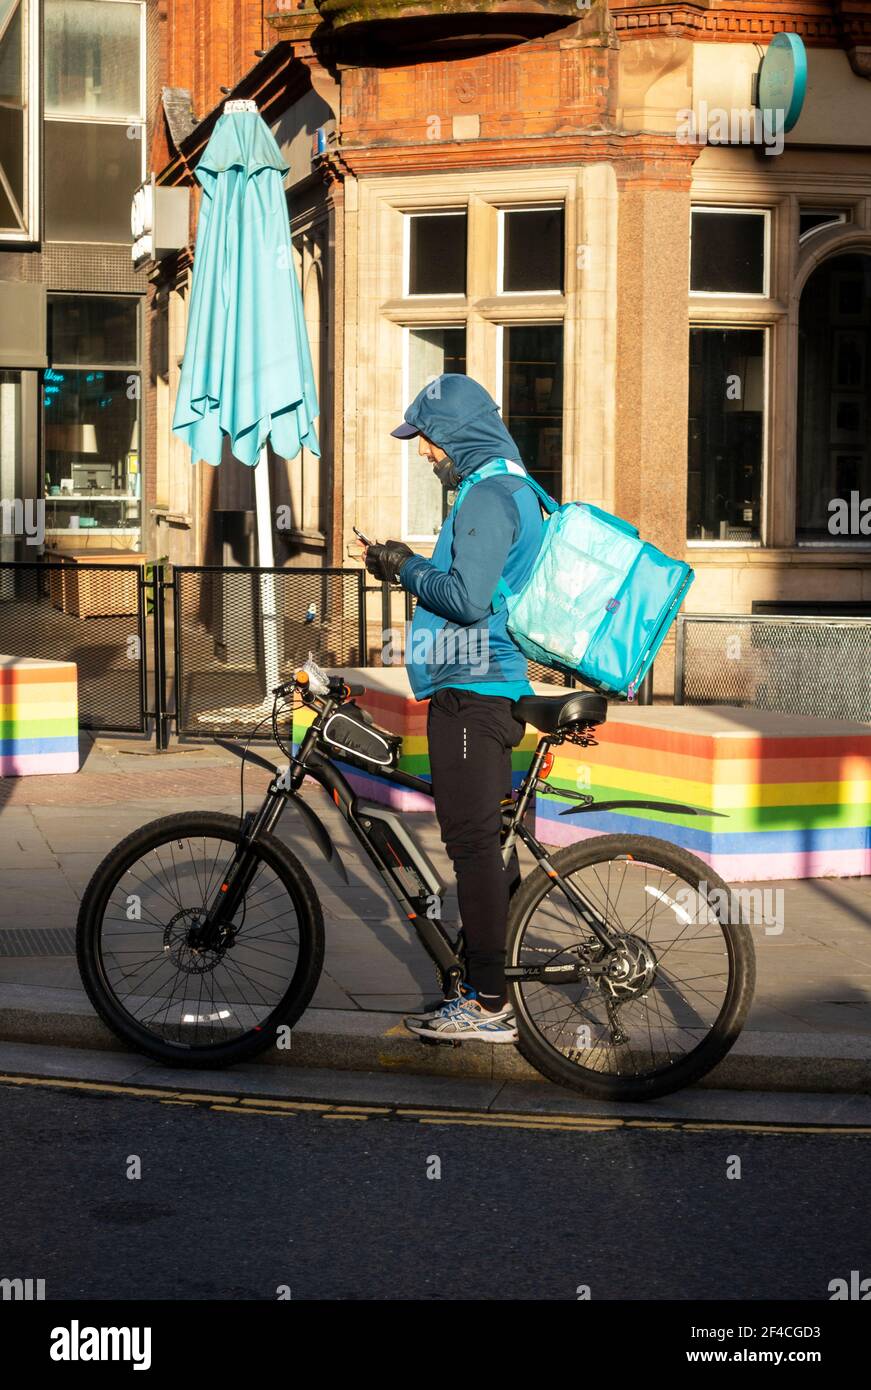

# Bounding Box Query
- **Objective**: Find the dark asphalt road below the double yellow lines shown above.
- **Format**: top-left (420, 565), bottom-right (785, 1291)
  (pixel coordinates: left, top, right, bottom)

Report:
top-left (0, 1084), bottom-right (871, 1301)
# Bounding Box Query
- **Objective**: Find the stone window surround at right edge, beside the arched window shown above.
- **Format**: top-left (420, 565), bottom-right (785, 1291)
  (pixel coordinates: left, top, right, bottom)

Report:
top-left (686, 165), bottom-right (871, 567)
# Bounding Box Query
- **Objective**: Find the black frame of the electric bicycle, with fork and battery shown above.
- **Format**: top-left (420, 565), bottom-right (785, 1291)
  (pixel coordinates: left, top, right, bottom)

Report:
top-left (197, 683), bottom-right (708, 988)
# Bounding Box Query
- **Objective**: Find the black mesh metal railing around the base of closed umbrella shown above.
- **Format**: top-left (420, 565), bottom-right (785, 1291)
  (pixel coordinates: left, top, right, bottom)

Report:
top-left (0, 552), bottom-right (661, 748)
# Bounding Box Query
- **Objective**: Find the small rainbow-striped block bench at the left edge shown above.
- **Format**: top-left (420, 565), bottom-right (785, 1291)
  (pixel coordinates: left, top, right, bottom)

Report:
top-left (0, 656), bottom-right (79, 777)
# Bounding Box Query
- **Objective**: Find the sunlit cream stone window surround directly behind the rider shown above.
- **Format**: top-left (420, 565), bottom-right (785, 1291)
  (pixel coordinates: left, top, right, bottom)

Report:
top-left (345, 164), bottom-right (617, 550)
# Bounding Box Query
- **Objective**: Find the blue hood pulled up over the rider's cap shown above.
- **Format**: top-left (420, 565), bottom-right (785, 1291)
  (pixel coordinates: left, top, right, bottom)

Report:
top-left (406, 373), bottom-right (522, 478)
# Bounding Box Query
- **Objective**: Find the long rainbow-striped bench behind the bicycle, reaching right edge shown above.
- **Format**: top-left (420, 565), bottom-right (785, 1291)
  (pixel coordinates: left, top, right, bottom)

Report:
top-left (293, 667), bottom-right (871, 881)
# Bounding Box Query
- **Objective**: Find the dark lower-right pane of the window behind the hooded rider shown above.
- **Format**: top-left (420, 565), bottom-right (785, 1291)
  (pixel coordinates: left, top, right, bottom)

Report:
top-left (501, 324), bottom-right (563, 500)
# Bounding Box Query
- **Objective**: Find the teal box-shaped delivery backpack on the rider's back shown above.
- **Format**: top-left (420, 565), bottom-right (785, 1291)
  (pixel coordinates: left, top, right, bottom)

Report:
top-left (457, 459), bottom-right (695, 699)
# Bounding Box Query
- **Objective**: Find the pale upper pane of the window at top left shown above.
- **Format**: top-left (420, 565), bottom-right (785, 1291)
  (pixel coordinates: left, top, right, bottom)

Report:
top-left (44, 0), bottom-right (142, 117)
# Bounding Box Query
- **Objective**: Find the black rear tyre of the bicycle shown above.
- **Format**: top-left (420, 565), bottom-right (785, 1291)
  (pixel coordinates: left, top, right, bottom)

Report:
top-left (506, 835), bottom-right (756, 1101)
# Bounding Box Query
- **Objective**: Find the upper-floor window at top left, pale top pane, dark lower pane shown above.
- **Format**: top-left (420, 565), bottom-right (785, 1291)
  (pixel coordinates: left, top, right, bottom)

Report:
top-left (43, 0), bottom-right (144, 243)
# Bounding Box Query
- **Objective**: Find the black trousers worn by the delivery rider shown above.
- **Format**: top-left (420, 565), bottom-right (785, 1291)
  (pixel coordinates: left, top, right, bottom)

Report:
top-left (426, 687), bottom-right (525, 1008)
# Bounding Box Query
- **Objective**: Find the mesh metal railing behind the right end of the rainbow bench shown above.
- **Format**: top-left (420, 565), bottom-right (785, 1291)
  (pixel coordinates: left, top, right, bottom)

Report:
top-left (675, 613), bottom-right (871, 721)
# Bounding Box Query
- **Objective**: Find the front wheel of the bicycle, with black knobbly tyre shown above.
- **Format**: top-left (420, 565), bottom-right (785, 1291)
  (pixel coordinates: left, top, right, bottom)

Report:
top-left (76, 812), bottom-right (324, 1066)
